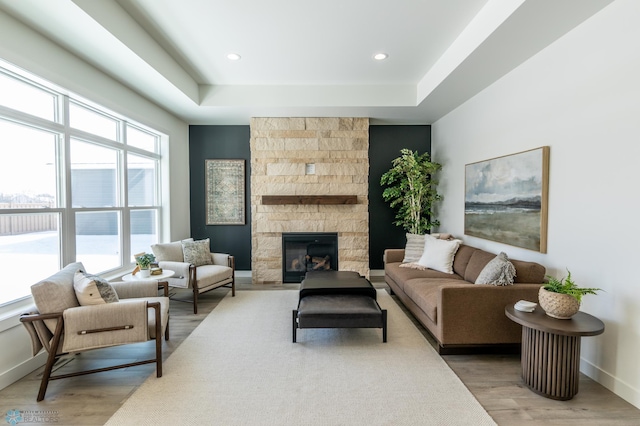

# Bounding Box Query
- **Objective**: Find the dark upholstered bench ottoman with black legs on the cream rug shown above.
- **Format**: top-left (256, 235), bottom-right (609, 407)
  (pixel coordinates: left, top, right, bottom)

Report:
top-left (293, 271), bottom-right (387, 343)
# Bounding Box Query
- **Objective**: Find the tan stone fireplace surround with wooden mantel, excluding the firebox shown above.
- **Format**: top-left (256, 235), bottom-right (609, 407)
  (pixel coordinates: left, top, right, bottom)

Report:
top-left (251, 117), bottom-right (369, 284)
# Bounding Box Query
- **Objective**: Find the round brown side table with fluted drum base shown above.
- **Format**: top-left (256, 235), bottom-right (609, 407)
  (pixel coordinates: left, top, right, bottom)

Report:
top-left (504, 305), bottom-right (604, 400)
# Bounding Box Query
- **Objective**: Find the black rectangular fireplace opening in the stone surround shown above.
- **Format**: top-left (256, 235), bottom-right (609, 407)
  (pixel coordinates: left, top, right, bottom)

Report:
top-left (282, 232), bottom-right (338, 283)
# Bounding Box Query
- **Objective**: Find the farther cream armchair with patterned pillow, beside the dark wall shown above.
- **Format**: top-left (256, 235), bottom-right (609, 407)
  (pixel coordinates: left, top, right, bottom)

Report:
top-left (151, 238), bottom-right (236, 314)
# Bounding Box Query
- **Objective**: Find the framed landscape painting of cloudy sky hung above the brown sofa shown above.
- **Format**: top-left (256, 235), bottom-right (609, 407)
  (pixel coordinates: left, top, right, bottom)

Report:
top-left (464, 146), bottom-right (549, 253)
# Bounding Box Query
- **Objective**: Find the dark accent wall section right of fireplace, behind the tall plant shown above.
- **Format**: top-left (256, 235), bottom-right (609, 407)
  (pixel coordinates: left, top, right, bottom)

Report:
top-left (369, 125), bottom-right (431, 269)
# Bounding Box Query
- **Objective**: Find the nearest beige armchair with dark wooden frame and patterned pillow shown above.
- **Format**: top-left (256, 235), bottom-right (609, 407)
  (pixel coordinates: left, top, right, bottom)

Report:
top-left (20, 262), bottom-right (169, 401)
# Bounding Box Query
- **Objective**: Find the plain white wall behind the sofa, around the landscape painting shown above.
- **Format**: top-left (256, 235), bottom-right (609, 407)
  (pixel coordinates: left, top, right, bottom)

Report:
top-left (432, 0), bottom-right (640, 407)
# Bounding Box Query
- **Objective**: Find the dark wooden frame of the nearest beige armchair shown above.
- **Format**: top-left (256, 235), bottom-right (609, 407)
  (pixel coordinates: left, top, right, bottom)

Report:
top-left (20, 282), bottom-right (169, 401)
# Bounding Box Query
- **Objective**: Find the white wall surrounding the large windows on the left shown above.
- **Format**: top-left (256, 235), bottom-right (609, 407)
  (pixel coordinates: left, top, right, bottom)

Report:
top-left (0, 12), bottom-right (190, 390)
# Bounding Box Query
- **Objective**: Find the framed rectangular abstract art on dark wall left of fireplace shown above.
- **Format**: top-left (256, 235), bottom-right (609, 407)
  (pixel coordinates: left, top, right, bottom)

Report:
top-left (205, 160), bottom-right (245, 225)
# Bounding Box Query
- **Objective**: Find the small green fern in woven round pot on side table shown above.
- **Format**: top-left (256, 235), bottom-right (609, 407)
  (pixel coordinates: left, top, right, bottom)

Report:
top-left (538, 269), bottom-right (602, 319)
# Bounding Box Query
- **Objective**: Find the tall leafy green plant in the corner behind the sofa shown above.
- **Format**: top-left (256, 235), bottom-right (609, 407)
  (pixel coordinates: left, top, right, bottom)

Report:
top-left (380, 148), bottom-right (442, 234)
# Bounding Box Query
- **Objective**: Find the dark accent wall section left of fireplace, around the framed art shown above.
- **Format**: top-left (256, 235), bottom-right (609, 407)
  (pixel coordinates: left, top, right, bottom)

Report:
top-left (189, 126), bottom-right (251, 271)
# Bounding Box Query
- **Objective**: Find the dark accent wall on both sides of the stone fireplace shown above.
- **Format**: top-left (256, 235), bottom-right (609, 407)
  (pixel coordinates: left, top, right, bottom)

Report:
top-left (189, 126), bottom-right (431, 271)
